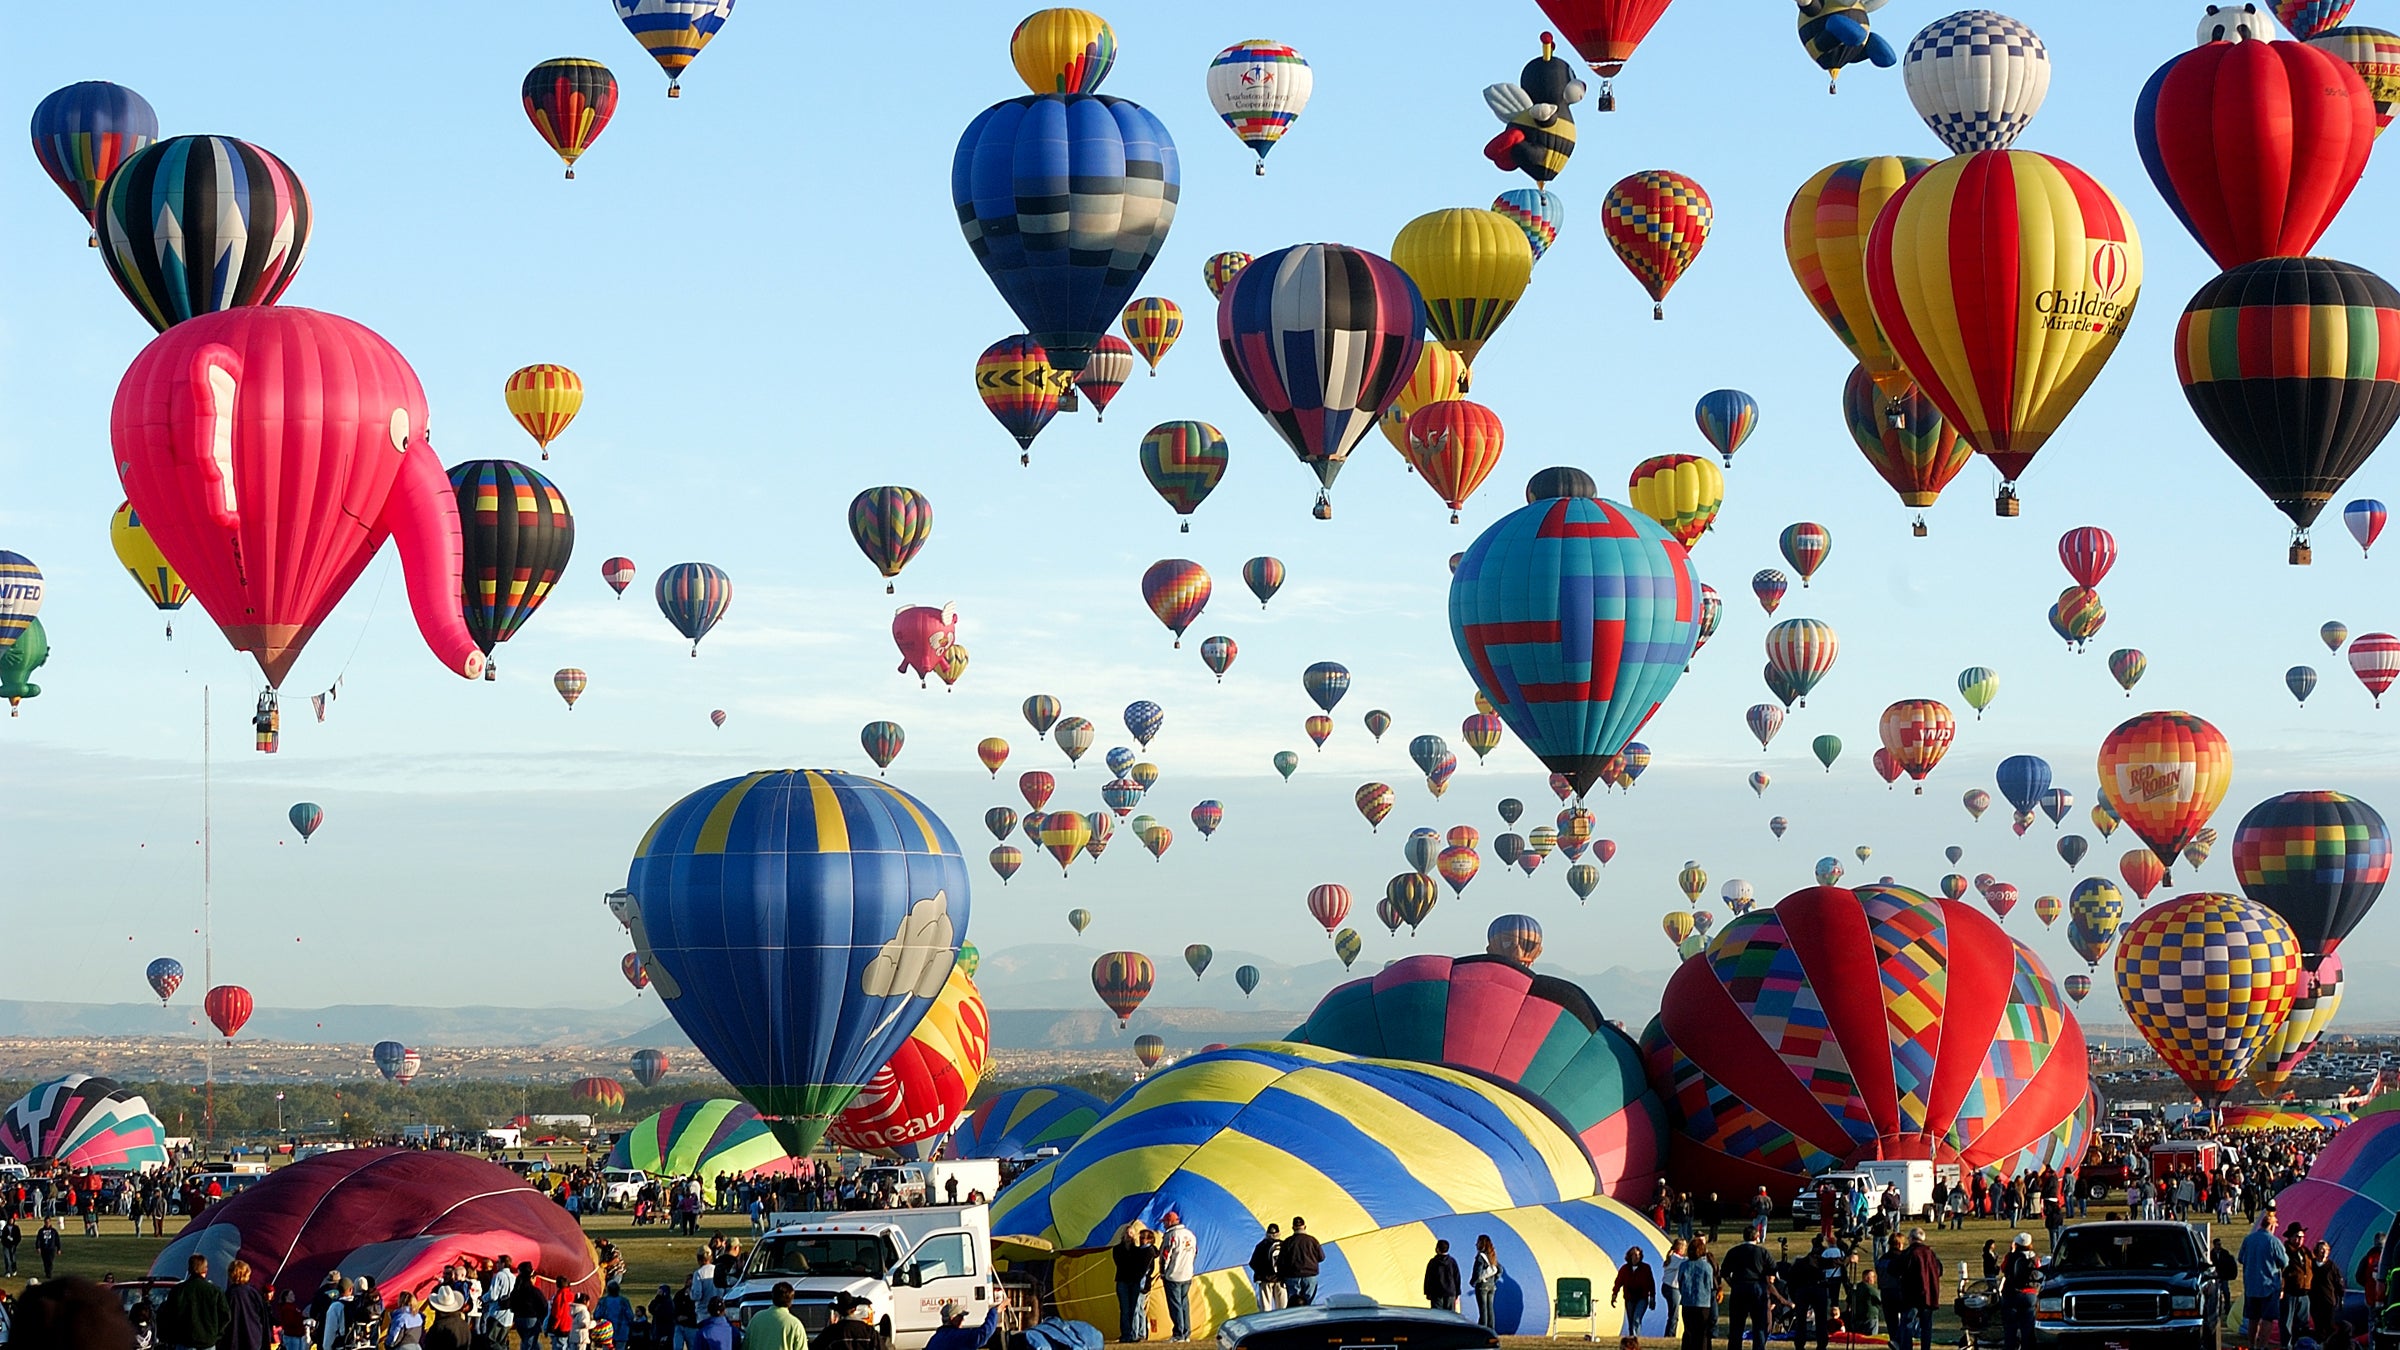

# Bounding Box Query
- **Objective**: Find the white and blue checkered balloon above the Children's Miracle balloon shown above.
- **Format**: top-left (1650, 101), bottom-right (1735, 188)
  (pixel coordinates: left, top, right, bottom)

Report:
top-left (1901, 10), bottom-right (2050, 154)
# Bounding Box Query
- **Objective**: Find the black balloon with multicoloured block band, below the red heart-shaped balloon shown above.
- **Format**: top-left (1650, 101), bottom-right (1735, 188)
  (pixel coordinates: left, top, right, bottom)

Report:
top-left (2174, 260), bottom-right (2400, 562)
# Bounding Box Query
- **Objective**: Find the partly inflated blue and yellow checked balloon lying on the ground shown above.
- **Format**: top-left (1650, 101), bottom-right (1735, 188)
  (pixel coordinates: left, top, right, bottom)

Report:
top-left (991, 1043), bottom-right (1663, 1336)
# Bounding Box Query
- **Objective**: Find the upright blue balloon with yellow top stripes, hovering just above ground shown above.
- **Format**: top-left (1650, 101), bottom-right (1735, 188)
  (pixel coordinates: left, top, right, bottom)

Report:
top-left (610, 769), bottom-right (967, 1155)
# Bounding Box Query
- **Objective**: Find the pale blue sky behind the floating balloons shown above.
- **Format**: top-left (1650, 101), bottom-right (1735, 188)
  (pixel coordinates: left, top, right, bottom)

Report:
top-left (0, 0), bottom-right (2400, 1019)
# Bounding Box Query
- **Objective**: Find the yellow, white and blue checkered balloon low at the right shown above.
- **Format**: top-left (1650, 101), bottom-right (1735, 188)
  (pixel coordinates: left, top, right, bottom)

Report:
top-left (2117, 888), bottom-right (2306, 1110)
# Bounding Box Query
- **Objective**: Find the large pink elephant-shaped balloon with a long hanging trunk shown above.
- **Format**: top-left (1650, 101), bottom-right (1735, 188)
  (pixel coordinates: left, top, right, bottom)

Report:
top-left (108, 305), bottom-right (482, 685)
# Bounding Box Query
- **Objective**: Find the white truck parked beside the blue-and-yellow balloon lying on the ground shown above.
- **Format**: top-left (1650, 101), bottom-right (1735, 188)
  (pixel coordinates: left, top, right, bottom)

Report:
top-left (725, 1206), bottom-right (998, 1350)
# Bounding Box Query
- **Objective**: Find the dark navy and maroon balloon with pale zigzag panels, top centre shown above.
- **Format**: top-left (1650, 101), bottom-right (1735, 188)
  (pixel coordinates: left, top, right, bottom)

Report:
top-left (1217, 245), bottom-right (1426, 519)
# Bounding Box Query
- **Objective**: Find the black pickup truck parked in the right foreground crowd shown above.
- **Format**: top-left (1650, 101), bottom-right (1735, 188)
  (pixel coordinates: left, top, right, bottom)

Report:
top-left (2033, 1223), bottom-right (2222, 1350)
